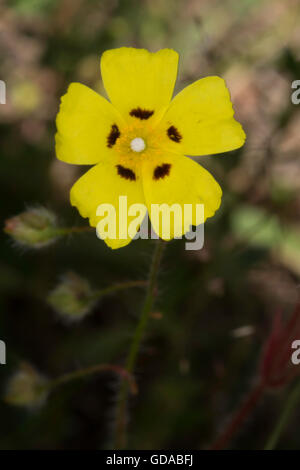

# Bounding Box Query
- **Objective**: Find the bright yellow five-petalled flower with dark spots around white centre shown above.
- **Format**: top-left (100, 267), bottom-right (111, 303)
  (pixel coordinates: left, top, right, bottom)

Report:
top-left (56, 47), bottom-right (245, 248)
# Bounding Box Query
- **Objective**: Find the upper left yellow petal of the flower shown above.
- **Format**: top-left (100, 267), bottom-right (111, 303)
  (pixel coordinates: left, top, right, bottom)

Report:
top-left (55, 83), bottom-right (122, 165)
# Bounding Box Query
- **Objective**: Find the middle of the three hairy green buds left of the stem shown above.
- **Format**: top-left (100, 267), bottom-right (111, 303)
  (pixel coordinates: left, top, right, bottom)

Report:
top-left (48, 272), bottom-right (96, 322)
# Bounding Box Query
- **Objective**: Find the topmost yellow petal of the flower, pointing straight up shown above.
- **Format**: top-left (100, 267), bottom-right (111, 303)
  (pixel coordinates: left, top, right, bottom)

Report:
top-left (101, 47), bottom-right (178, 123)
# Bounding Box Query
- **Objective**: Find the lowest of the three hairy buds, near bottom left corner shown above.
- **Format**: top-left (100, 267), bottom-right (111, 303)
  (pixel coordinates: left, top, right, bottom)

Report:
top-left (4, 363), bottom-right (47, 408)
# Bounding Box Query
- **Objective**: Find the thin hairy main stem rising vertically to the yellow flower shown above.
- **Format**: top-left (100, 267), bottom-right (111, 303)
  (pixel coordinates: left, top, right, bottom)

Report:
top-left (114, 240), bottom-right (165, 449)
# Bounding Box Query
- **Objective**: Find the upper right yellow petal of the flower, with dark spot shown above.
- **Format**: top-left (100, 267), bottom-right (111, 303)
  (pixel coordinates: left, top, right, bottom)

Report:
top-left (159, 77), bottom-right (246, 155)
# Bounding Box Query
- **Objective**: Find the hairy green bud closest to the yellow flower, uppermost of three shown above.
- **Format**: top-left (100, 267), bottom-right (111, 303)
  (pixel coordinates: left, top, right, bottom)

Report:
top-left (4, 207), bottom-right (58, 248)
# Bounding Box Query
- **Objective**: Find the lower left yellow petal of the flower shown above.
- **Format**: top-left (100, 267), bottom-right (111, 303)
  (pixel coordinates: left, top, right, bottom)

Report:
top-left (70, 162), bottom-right (147, 249)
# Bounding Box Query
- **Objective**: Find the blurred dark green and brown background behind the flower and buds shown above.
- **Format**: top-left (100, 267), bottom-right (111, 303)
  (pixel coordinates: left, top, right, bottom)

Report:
top-left (0, 0), bottom-right (300, 449)
